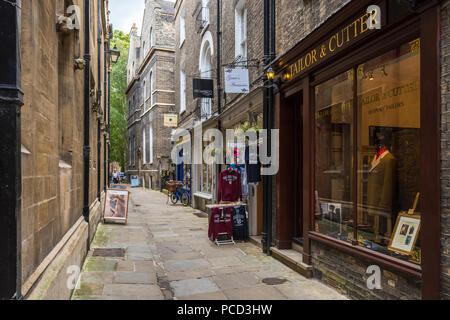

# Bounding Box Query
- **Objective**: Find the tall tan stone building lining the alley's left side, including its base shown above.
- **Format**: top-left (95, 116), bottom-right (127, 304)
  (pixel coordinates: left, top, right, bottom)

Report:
top-left (0, 0), bottom-right (111, 299)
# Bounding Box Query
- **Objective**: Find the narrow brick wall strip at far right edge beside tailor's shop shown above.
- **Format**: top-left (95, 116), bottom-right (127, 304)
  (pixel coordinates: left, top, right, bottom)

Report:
top-left (441, 0), bottom-right (450, 300)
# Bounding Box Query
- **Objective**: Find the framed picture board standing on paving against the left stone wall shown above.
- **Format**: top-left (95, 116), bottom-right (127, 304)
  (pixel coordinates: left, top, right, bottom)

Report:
top-left (103, 189), bottom-right (130, 224)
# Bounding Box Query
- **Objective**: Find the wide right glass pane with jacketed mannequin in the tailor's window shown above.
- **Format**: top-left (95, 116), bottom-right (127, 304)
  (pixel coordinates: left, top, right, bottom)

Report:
top-left (357, 40), bottom-right (420, 264)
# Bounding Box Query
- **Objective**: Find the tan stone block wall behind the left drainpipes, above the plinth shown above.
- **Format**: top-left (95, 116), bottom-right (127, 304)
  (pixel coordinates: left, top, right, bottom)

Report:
top-left (21, 0), bottom-right (107, 296)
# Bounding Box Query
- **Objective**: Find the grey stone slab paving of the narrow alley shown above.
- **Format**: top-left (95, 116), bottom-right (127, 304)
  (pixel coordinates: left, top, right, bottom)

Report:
top-left (73, 189), bottom-right (345, 300)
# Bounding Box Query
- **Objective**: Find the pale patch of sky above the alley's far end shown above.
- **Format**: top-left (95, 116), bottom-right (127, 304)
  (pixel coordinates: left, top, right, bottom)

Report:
top-left (109, 0), bottom-right (175, 34)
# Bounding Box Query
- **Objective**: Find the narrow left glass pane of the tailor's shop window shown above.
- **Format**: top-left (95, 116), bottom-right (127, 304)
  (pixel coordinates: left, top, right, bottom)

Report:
top-left (315, 71), bottom-right (353, 242)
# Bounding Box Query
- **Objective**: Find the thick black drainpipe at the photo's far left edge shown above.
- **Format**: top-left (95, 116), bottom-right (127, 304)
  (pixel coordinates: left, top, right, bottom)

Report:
top-left (0, 0), bottom-right (23, 300)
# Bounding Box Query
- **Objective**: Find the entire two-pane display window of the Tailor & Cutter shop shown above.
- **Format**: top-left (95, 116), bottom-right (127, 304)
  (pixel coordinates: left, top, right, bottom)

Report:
top-left (315, 39), bottom-right (421, 265)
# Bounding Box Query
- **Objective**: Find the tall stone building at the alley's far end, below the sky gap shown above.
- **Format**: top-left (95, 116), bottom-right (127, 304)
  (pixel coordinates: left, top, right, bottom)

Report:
top-left (126, 0), bottom-right (175, 189)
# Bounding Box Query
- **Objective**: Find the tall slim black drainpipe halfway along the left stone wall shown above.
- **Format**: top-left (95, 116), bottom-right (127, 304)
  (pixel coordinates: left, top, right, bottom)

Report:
top-left (83, 0), bottom-right (91, 225)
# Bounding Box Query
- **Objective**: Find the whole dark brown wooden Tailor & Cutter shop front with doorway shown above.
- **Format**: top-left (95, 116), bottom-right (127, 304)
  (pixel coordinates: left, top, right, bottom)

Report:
top-left (274, 1), bottom-right (441, 299)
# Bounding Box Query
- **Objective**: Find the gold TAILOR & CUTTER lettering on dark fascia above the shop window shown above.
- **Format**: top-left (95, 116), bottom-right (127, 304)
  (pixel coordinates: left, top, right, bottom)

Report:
top-left (283, 8), bottom-right (381, 81)
